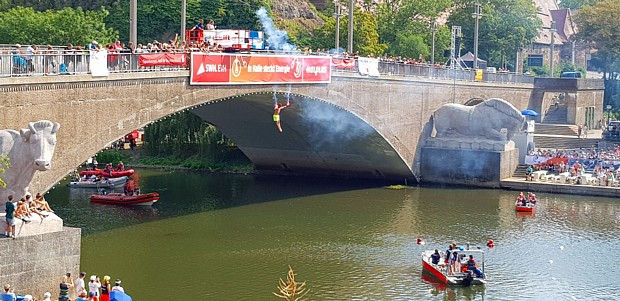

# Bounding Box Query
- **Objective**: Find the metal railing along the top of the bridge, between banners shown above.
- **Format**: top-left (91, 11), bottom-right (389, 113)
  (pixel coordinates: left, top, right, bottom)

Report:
top-left (0, 49), bottom-right (534, 84)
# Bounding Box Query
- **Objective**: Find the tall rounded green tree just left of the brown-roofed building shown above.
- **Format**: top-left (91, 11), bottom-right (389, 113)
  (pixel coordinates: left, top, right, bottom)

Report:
top-left (448, 0), bottom-right (542, 66)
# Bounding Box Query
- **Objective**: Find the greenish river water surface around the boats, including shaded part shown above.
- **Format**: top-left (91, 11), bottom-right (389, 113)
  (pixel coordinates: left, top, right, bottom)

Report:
top-left (47, 170), bottom-right (620, 301)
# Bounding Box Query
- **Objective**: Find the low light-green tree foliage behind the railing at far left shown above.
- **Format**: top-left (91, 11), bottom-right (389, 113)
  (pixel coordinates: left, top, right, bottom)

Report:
top-left (0, 7), bottom-right (116, 45)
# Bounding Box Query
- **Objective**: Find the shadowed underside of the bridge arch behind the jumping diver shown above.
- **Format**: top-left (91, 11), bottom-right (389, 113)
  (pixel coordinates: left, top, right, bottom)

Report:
top-left (189, 91), bottom-right (413, 179)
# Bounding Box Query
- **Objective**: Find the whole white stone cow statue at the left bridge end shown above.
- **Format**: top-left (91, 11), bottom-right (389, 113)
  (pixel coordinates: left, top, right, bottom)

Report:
top-left (0, 120), bottom-right (60, 212)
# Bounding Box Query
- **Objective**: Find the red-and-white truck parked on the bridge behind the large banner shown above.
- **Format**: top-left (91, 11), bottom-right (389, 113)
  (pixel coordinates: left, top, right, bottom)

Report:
top-left (185, 29), bottom-right (265, 52)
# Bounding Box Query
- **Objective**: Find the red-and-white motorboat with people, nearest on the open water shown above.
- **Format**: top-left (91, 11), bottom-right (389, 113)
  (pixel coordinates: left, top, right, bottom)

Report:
top-left (422, 244), bottom-right (487, 286)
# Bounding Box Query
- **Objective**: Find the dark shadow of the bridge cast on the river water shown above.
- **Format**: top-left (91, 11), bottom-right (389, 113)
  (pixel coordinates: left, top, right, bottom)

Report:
top-left (45, 169), bottom-right (393, 235)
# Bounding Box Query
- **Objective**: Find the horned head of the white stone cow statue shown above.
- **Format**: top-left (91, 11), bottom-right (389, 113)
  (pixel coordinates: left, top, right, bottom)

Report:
top-left (20, 120), bottom-right (60, 171)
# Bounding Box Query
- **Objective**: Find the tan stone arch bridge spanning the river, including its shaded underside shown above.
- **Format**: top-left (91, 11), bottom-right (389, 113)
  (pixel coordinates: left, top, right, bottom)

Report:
top-left (0, 71), bottom-right (594, 192)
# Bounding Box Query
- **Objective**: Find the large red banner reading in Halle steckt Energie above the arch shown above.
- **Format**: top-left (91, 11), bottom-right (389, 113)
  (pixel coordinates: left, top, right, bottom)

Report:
top-left (190, 52), bottom-right (331, 85)
